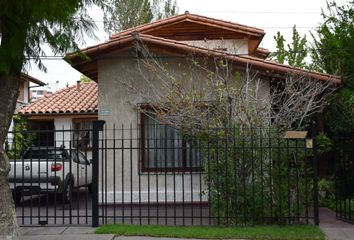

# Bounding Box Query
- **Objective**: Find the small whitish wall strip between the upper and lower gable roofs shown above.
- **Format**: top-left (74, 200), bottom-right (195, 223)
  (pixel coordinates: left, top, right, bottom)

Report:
top-left (181, 39), bottom-right (248, 55)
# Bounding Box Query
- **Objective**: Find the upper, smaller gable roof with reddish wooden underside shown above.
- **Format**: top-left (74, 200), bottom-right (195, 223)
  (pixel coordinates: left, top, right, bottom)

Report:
top-left (111, 11), bottom-right (265, 53)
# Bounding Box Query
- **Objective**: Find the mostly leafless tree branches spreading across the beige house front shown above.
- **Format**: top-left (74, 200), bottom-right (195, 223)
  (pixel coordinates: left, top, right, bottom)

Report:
top-left (119, 43), bottom-right (336, 130)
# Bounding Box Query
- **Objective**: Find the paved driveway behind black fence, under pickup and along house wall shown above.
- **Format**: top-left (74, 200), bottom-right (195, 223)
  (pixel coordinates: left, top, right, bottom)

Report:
top-left (16, 189), bottom-right (210, 226)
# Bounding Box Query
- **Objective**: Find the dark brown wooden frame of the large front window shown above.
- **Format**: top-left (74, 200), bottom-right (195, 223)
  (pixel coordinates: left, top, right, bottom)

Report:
top-left (138, 104), bottom-right (203, 173)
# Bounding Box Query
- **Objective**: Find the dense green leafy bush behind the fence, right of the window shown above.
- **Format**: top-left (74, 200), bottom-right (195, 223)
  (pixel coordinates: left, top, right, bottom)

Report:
top-left (201, 128), bottom-right (312, 225)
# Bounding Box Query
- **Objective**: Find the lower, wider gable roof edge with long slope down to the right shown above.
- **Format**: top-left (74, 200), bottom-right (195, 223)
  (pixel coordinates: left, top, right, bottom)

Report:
top-left (67, 33), bottom-right (341, 84)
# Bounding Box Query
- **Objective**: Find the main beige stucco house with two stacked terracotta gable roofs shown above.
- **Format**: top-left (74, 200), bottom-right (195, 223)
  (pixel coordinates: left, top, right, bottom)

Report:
top-left (67, 12), bottom-right (340, 202)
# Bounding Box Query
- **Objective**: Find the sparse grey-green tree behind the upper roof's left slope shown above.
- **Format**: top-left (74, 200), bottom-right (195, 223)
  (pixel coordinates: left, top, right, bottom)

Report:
top-left (103, 0), bottom-right (178, 34)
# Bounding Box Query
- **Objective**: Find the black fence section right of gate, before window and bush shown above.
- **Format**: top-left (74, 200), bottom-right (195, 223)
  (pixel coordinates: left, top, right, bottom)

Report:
top-left (94, 123), bottom-right (318, 225)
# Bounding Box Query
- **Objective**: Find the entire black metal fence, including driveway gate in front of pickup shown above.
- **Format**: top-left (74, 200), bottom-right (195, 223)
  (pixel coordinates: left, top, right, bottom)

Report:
top-left (6, 121), bottom-right (318, 226)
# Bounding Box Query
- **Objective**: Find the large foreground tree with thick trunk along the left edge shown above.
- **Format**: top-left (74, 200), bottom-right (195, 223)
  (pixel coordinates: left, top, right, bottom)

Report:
top-left (0, 0), bottom-right (104, 239)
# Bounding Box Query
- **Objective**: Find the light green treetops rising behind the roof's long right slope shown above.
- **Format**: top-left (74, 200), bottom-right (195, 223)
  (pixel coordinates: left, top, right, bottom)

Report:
top-left (270, 25), bottom-right (308, 68)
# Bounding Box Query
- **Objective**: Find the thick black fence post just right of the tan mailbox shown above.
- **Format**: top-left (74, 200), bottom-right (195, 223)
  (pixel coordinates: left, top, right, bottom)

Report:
top-left (312, 122), bottom-right (320, 226)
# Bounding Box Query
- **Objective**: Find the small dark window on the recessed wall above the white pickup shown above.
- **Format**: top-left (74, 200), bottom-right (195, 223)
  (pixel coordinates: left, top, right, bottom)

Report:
top-left (73, 120), bottom-right (93, 150)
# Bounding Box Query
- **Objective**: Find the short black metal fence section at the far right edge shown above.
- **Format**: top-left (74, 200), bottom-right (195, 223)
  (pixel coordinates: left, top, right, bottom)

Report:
top-left (334, 136), bottom-right (354, 224)
